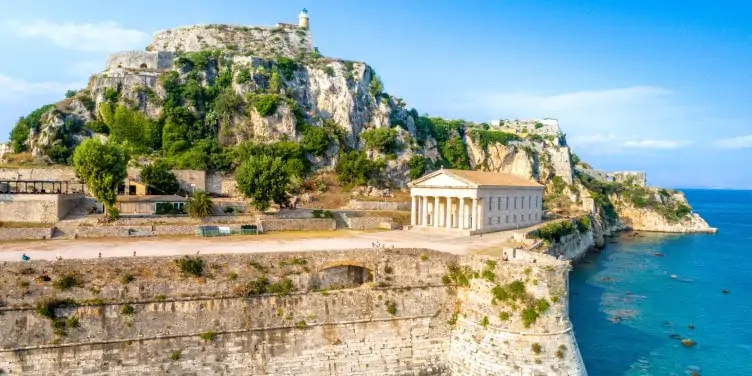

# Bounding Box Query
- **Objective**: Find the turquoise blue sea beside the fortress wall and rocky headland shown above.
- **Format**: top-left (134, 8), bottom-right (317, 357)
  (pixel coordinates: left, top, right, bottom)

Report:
top-left (570, 190), bottom-right (752, 376)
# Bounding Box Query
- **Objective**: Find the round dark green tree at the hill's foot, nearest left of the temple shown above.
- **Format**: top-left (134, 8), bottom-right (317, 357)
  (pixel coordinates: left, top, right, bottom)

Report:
top-left (235, 155), bottom-right (290, 211)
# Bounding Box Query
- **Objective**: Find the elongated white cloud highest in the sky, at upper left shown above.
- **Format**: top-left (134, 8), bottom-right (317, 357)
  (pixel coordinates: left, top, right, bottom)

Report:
top-left (8, 20), bottom-right (149, 52)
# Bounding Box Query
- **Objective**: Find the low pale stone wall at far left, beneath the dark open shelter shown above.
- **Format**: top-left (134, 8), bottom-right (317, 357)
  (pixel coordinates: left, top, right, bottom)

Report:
top-left (0, 194), bottom-right (83, 223)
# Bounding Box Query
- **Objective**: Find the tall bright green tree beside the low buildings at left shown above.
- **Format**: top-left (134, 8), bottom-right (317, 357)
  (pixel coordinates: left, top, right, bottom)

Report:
top-left (73, 138), bottom-right (128, 213)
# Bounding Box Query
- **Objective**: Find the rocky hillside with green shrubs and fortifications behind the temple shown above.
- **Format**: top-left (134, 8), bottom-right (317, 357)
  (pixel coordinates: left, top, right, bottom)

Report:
top-left (0, 25), bottom-right (709, 232)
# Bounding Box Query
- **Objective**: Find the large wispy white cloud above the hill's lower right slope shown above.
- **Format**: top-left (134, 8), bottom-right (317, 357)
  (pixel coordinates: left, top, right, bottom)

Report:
top-left (458, 86), bottom-right (702, 152)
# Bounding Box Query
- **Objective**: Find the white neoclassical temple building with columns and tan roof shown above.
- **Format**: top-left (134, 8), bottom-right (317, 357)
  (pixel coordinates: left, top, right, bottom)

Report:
top-left (407, 169), bottom-right (544, 234)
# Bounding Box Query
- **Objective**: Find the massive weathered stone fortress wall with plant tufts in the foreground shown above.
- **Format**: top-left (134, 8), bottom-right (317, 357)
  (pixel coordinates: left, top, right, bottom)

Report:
top-left (0, 249), bottom-right (586, 376)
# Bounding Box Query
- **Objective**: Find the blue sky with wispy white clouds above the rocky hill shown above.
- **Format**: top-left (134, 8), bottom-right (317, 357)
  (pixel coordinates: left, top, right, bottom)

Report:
top-left (0, 0), bottom-right (752, 188)
